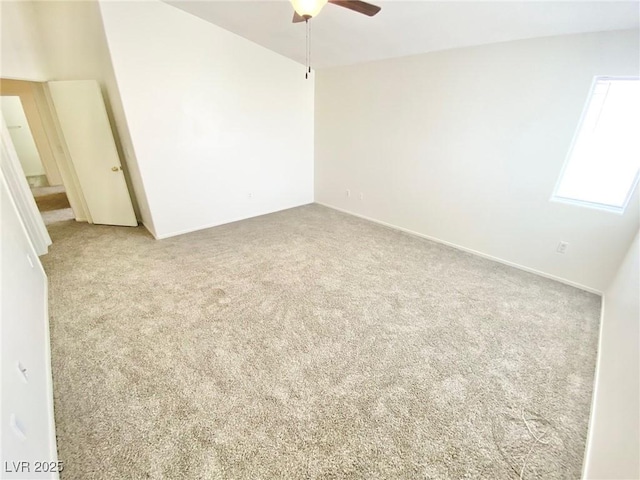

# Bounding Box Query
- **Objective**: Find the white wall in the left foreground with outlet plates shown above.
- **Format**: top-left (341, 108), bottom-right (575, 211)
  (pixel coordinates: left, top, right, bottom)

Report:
top-left (0, 168), bottom-right (58, 479)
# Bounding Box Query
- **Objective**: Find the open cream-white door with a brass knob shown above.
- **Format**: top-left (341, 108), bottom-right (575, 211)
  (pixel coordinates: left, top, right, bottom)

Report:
top-left (48, 80), bottom-right (138, 226)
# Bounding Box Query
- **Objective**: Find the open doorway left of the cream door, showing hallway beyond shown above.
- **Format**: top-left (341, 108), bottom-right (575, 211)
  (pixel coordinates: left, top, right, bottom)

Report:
top-left (0, 95), bottom-right (75, 225)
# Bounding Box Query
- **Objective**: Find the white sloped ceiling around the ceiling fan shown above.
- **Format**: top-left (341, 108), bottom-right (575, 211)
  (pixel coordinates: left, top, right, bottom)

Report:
top-left (166, 0), bottom-right (640, 68)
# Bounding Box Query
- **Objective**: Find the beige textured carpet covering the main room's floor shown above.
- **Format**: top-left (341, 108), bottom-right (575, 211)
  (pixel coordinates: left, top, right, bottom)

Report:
top-left (42, 205), bottom-right (600, 479)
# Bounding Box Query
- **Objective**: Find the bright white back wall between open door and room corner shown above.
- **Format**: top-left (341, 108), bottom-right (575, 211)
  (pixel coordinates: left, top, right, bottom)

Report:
top-left (100, 1), bottom-right (314, 238)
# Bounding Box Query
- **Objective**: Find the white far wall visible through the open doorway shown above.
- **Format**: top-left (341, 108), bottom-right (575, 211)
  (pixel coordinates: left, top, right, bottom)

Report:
top-left (0, 96), bottom-right (45, 177)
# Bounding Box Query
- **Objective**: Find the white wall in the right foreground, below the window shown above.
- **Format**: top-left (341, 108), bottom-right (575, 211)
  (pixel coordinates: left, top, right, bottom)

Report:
top-left (584, 233), bottom-right (640, 480)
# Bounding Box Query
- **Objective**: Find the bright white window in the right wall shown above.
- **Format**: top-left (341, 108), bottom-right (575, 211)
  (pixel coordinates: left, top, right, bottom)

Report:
top-left (551, 77), bottom-right (640, 213)
